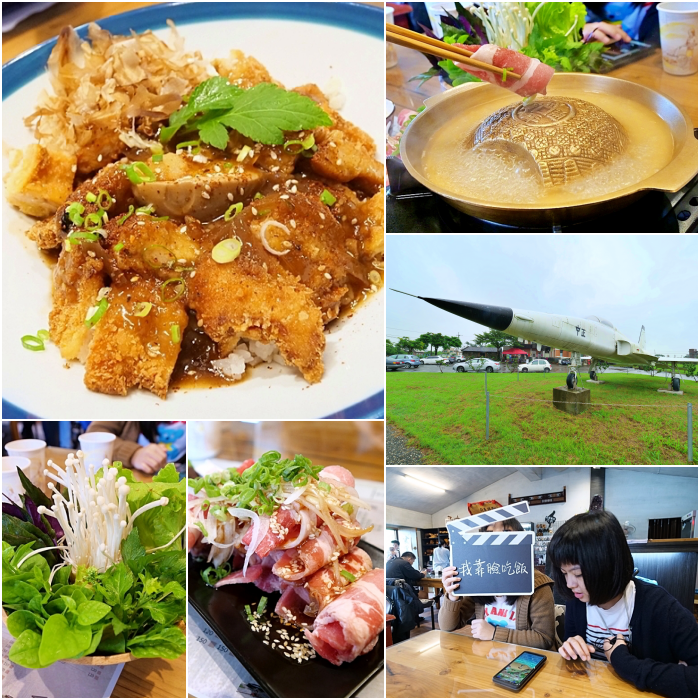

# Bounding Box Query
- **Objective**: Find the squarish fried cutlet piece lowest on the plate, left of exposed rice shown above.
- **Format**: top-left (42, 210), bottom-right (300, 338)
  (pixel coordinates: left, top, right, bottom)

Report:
top-left (85, 273), bottom-right (188, 399)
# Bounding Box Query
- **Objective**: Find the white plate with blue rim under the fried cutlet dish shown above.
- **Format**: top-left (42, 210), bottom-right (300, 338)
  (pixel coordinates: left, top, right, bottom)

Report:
top-left (2, 2), bottom-right (384, 418)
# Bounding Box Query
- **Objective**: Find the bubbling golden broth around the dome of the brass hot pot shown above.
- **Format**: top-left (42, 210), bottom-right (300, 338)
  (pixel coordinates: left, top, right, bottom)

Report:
top-left (423, 87), bottom-right (673, 206)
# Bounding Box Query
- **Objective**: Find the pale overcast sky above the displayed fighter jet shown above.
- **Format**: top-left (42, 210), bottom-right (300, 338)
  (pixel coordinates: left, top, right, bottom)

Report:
top-left (386, 235), bottom-right (698, 353)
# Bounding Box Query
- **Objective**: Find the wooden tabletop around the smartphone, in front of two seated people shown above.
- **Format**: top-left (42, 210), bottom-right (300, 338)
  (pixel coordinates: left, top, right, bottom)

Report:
top-left (386, 630), bottom-right (663, 698)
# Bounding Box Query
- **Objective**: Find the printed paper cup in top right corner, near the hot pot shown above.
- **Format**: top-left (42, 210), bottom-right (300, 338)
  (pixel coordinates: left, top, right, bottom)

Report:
top-left (656, 2), bottom-right (698, 75)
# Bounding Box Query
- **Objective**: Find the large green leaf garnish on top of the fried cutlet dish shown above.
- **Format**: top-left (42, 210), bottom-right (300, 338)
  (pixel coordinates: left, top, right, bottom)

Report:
top-left (160, 76), bottom-right (333, 150)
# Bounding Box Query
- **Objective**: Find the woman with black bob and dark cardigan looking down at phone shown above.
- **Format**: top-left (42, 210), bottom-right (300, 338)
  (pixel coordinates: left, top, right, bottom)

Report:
top-left (547, 510), bottom-right (698, 698)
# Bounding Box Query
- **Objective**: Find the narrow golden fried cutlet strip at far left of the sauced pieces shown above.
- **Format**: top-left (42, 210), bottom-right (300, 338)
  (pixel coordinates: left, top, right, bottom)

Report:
top-left (49, 245), bottom-right (105, 360)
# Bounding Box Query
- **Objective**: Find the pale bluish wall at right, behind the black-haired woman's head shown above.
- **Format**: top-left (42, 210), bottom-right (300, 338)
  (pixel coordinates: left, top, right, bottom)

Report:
top-left (605, 469), bottom-right (698, 539)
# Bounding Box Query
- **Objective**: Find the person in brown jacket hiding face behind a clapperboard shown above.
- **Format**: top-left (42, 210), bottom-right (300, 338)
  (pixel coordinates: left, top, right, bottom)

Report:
top-left (438, 518), bottom-right (554, 649)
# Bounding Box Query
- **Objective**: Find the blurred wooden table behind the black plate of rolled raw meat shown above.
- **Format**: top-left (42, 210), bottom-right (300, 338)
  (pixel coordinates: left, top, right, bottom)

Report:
top-left (188, 420), bottom-right (384, 481)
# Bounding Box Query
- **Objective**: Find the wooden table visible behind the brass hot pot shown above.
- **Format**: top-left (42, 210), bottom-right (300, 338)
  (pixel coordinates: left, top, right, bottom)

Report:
top-left (386, 46), bottom-right (698, 125)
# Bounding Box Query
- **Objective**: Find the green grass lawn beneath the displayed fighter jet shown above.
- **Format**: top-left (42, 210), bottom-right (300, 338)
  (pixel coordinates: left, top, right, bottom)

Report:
top-left (386, 370), bottom-right (698, 465)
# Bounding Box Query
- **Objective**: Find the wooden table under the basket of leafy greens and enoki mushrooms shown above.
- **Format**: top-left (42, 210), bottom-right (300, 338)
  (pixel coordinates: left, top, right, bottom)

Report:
top-left (46, 446), bottom-right (187, 698)
